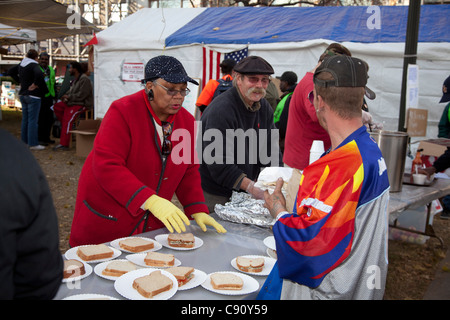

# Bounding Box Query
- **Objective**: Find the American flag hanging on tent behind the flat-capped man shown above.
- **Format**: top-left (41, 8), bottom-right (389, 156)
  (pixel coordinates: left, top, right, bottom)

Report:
top-left (202, 47), bottom-right (248, 87)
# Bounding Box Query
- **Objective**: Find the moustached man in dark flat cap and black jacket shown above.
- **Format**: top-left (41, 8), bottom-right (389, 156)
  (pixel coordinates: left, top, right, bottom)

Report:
top-left (199, 56), bottom-right (281, 211)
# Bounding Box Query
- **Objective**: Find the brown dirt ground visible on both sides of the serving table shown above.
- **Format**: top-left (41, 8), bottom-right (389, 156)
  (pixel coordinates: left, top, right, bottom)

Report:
top-left (0, 108), bottom-right (450, 300)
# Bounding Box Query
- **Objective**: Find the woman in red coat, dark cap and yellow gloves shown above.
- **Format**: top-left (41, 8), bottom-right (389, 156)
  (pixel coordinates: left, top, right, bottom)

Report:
top-left (70, 56), bottom-right (226, 247)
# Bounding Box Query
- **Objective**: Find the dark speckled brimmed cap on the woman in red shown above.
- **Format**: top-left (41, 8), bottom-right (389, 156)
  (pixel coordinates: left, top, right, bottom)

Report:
top-left (142, 56), bottom-right (198, 85)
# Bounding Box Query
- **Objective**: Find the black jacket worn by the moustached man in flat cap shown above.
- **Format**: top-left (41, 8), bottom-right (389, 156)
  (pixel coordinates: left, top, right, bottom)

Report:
top-left (200, 87), bottom-right (283, 197)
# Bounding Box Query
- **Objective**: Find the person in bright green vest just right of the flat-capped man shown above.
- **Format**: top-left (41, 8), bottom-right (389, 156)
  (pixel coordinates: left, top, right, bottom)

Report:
top-left (273, 71), bottom-right (298, 152)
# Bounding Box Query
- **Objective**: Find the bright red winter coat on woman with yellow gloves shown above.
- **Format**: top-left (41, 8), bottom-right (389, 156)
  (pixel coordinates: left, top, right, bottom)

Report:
top-left (70, 90), bottom-right (208, 247)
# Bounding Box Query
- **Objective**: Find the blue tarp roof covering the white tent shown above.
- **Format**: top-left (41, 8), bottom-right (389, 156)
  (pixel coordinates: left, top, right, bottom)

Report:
top-left (166, 5), bottom-right (450, 46)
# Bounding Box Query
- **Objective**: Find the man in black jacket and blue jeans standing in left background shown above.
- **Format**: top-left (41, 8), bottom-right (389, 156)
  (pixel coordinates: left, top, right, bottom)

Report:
top-left (9, 49), bottom-right (48, 150)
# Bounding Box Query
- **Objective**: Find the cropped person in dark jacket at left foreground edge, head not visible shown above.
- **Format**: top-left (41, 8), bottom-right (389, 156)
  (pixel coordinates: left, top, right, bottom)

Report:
top-left (0, 129), bottom-right (63, 300)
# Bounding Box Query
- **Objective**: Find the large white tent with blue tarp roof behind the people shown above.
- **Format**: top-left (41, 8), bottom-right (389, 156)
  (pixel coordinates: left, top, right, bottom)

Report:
top-left (94, 5), bottom-right (450, 138)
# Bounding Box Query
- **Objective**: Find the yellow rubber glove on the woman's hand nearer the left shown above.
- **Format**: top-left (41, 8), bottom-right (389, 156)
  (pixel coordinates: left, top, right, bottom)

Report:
top-left (144, 194), bottom-right (190, 233)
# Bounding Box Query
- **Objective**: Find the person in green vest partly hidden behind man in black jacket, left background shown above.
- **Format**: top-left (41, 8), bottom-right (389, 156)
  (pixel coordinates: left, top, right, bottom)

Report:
top-left (38, 51), bottom-right (56, 146)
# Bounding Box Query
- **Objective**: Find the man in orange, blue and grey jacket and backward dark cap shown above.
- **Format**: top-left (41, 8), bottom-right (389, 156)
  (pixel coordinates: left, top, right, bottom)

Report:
top-left (258, 55), bottom-right (390, 300)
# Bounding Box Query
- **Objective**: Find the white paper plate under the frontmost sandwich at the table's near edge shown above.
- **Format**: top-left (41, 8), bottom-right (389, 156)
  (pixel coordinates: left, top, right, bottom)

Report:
top-left (114, 268), bottom-right (178, 300)
